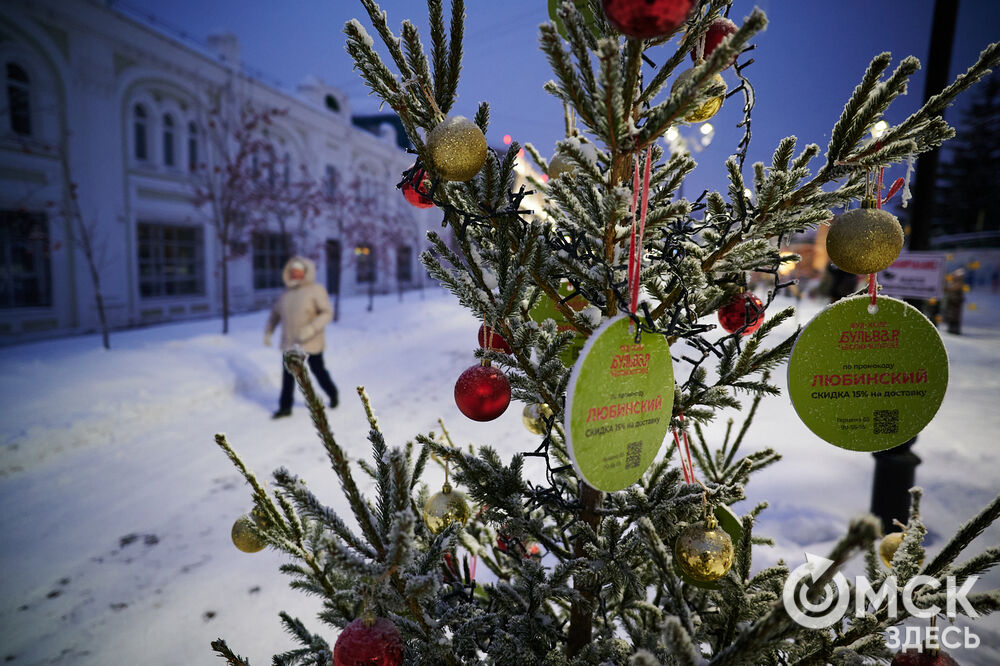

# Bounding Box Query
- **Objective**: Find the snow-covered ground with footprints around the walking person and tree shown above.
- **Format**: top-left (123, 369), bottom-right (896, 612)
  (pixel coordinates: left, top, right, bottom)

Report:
top-left (0, 290), bottom-right (1000, 666)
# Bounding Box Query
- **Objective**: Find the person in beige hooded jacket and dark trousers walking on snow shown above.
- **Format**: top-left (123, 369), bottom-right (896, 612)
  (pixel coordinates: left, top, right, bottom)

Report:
top-left (264, 257), bottom-right (337, 419)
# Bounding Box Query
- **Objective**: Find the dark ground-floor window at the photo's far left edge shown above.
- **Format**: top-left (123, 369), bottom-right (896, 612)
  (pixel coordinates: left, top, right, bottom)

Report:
top-left (0, 210), bottom-right (52, 308)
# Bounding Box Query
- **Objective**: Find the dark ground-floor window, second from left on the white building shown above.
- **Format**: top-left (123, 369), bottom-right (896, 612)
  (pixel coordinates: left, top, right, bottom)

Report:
top-left (138, 222), bottom-right (205, 298)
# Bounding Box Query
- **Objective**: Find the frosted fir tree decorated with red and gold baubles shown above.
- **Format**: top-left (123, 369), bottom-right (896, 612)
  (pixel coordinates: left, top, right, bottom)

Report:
top-left (213, 0), bottom-right (1000, 666)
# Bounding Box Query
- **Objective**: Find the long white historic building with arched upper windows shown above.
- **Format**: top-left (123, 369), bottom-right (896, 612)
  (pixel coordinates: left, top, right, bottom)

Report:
top-left (0, 0), bottom-right (440, 343)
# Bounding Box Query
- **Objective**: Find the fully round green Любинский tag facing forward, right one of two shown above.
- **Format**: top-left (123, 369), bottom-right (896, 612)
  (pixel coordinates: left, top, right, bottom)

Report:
top-left (788, 296), bottom-right (948, 451)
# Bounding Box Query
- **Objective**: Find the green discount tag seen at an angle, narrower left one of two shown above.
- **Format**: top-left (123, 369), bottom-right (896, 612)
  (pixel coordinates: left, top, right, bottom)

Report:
top-left (565, 317), bottom-right (674, 492)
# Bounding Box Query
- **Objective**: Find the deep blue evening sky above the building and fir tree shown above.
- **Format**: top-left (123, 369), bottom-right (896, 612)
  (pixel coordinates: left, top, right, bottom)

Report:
top-left (120, 0), bottom-right (1000, 195)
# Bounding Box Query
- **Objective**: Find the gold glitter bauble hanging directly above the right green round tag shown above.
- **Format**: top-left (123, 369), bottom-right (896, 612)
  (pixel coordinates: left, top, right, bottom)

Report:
top-left (826, 201), bottom-right (903, 275)
